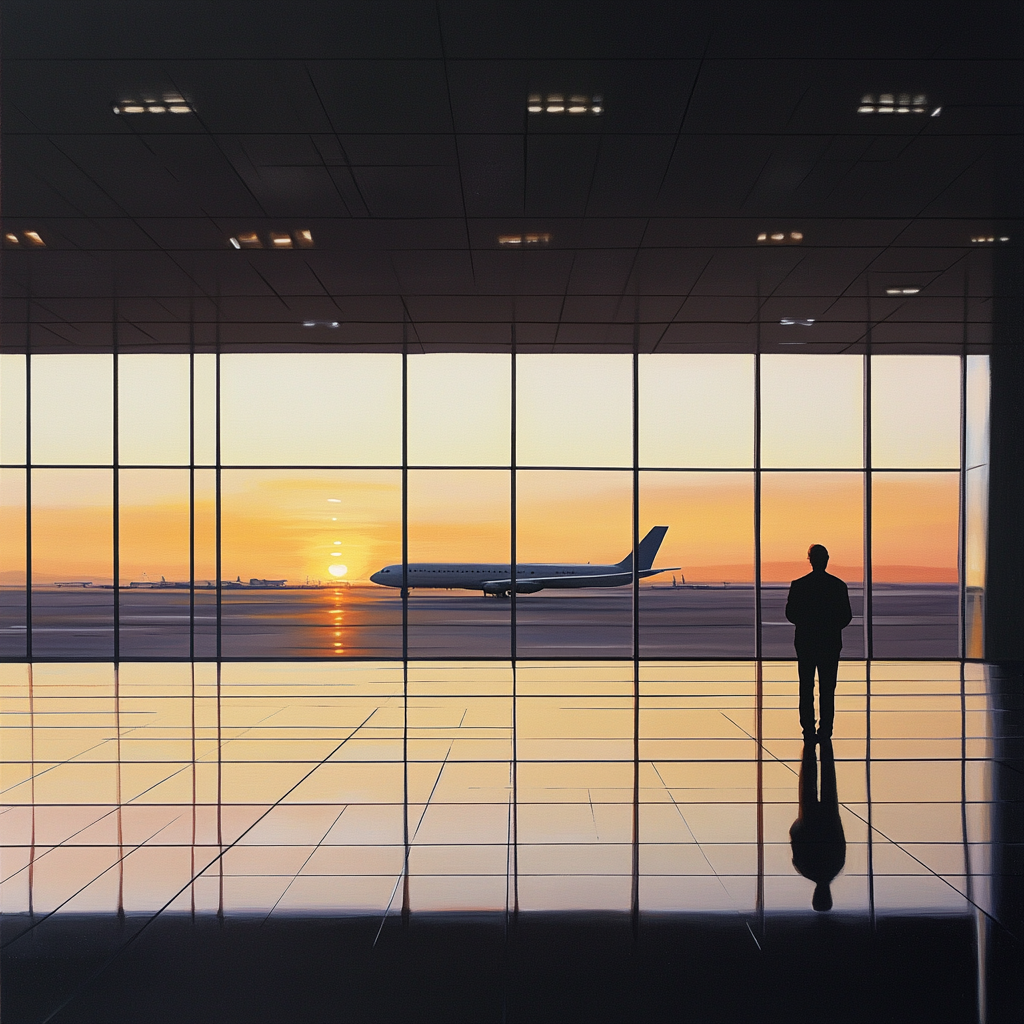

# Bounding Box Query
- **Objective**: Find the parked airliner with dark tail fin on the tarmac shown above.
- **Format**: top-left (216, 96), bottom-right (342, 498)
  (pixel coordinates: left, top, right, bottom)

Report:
top-left (370, 526), bottom-right (679, 597)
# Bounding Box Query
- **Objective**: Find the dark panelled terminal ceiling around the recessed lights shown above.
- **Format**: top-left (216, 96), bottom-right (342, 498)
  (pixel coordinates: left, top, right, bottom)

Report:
top-left (4, 0), bottom-right (1021, 356)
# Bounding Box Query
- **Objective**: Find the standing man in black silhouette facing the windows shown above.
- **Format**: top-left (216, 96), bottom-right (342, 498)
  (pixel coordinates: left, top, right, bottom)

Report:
top-left (785, 544), bottom-right (853, 740)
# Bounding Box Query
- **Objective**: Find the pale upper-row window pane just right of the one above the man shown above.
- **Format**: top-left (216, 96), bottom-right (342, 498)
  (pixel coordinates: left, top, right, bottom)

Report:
top-left (871, 355), bottom-right (961, 469)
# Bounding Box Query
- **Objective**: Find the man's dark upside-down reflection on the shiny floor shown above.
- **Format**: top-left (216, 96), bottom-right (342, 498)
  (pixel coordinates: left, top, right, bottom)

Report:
top-left (790, 739), bottom-right (846, 910)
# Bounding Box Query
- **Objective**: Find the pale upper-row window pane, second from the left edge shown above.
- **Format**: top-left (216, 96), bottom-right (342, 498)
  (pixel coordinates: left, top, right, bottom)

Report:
top-left (32, 353), bottom-right (114, 465)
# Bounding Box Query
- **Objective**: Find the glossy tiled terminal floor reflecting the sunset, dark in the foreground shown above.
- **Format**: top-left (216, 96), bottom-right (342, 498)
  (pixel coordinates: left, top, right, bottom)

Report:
top-left (0, 660), bottom-right (1022, 1022)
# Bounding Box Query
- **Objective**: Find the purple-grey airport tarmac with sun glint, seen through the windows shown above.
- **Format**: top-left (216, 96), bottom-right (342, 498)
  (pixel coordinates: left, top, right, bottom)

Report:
top-left (0, 584), bottom-right (959, 659)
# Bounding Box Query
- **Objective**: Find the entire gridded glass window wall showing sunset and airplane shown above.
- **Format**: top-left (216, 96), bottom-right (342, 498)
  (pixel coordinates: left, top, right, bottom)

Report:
top-left (0, 352), bottom-right (988, 659)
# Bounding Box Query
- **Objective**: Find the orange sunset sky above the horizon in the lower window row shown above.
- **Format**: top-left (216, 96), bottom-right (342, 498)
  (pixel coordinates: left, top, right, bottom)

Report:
top-left (9, 469), bottom-right (957, 583)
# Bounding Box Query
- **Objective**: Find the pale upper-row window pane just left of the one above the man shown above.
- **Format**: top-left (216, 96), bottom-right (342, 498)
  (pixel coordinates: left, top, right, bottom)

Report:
top-left (639, 354), bottom-right (754, 467)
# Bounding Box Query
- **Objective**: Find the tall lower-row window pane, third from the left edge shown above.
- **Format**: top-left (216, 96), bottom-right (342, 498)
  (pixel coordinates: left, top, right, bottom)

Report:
top-left (118, 469), bottom-right (189, 657)
